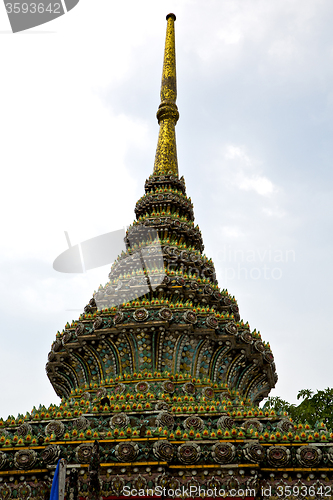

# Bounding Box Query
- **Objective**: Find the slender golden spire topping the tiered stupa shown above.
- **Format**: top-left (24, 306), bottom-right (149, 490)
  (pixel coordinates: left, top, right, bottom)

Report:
top-left (154, 14), bottom-right (179, 177)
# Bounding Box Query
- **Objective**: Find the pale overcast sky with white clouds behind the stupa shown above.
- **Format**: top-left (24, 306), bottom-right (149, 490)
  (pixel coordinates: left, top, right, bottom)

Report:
top-left (0, 0), bottom-right (333, 417)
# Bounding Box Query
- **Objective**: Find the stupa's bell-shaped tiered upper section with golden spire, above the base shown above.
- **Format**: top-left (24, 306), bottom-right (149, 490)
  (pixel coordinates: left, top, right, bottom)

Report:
top-left (46, 14), bottom-right (277, 405)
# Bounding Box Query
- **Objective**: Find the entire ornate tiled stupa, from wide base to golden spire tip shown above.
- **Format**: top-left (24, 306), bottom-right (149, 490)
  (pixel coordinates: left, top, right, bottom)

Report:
top-left (0, 14), bottom-right (333, 500)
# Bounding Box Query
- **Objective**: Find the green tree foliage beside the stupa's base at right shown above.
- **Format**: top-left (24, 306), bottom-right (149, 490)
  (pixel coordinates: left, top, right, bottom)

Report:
top-left (263, 388), bottom-right (333, 429)
